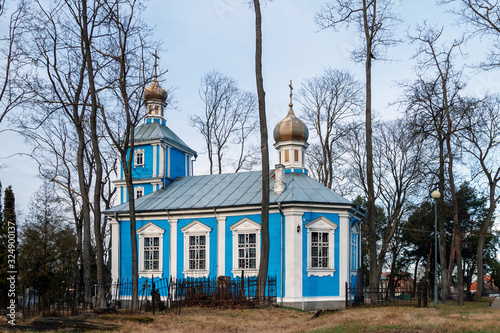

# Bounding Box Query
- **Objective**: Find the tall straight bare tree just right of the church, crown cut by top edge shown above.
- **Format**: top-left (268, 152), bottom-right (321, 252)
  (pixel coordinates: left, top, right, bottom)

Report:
top-left (316, 0), bottom-right (397, 289)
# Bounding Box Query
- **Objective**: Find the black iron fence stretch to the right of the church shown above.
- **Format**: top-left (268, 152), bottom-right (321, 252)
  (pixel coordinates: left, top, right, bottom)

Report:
top-left (345, 283), bottom-right (428, 308)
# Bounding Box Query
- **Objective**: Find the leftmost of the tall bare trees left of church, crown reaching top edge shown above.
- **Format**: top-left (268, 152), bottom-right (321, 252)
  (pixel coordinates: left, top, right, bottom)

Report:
top-left (16, 1), bottom-right (104, 302)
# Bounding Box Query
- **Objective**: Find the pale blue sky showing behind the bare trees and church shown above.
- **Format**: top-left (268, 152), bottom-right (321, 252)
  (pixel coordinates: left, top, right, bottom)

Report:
top-left (0, 0), bottom-right (500, 213)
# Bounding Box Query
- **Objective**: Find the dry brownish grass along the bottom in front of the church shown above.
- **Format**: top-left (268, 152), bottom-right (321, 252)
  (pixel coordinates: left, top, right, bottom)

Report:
top-left (94, 300), bottom-right (500, 333)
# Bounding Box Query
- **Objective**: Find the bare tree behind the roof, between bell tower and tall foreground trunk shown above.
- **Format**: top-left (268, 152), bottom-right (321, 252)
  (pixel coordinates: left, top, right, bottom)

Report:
top-left (190, 71), bottom-right (257, 174)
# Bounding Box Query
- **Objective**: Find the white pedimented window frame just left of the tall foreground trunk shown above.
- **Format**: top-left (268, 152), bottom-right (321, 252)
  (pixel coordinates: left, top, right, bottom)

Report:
top-left (229, 217), bottom-right (261, 276)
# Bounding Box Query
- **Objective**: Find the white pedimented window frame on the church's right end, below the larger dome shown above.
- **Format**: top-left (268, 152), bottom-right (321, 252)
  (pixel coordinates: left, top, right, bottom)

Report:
top-left (305, 216), bottom-right (338, 277)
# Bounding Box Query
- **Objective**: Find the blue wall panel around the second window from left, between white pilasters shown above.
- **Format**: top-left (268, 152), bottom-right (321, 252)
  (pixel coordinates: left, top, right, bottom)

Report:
top-left (177, 217), bottom-right (217, 278)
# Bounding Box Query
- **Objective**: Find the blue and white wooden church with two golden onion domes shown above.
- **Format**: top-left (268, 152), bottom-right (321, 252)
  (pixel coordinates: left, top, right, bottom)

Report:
top-left (106, 72), bottom-right (364, 310)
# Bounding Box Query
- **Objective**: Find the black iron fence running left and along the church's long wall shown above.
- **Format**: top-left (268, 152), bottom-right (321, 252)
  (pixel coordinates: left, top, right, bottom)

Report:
top-left (18, 276), bottom-right (277, 317)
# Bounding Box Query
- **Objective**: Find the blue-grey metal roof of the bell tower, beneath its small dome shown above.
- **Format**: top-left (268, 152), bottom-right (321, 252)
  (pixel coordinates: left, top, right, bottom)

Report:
top-left (134, 121), bottom-right (198, 157)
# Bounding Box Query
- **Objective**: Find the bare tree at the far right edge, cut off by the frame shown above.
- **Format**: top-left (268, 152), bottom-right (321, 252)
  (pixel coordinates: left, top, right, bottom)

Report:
top-left (460, 95), bottom-right (500, 297)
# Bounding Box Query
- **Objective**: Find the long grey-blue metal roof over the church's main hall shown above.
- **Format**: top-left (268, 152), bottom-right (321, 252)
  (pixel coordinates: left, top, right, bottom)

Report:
top-left (106, 171), bottom-right (353, 213)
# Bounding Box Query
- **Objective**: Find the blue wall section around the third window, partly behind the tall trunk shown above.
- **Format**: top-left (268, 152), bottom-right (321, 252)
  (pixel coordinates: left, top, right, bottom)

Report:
top-left (224, 213), bottom-right (285, 297)
